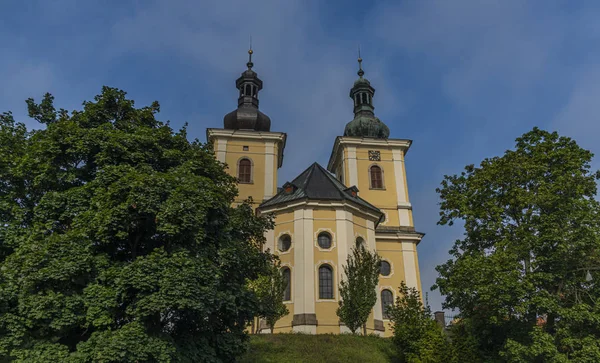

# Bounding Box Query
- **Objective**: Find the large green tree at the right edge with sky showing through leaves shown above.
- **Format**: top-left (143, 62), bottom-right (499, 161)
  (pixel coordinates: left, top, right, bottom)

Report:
top-left (437, 128), bottom-right (600, 362)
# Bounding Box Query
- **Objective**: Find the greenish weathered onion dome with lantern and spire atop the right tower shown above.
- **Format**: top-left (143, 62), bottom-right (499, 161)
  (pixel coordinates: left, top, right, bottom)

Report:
top-left (344, 53), bottom-right (390, 139)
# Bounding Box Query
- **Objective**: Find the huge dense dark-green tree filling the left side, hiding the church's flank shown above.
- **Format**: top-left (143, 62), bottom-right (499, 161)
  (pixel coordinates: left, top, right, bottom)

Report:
top-left (0, 87), bottom-right (272, 362)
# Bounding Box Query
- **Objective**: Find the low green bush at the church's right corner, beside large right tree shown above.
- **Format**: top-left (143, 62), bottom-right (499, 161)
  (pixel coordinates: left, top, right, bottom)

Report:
top-left (388, 282), bottom-right (448, 363)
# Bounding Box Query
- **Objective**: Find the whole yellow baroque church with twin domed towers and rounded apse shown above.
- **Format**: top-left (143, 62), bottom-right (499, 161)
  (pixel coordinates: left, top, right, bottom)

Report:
top-left (206, 50), bottom-right (424, 336)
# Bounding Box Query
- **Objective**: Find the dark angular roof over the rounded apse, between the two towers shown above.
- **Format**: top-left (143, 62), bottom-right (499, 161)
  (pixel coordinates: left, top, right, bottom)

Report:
top-left (259, 163), bottom-right (383, 220)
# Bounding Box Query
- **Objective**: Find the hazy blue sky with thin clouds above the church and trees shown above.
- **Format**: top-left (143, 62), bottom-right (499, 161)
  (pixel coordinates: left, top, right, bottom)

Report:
top-left (0, 0), bottom-right (600, 310)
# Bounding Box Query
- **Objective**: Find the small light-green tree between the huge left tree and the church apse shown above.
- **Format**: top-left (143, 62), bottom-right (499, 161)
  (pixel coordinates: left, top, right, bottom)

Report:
top-left (249, 262), bottom-right (289, 334)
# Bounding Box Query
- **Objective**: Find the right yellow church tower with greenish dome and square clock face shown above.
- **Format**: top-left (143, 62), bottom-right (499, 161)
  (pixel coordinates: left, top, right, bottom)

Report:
top-left (327, 56), bottom-right (423, 331)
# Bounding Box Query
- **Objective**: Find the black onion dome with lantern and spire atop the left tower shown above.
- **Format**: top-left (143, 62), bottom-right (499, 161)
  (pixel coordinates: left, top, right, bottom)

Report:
top-left (223, 49), bottom-right (271, 131)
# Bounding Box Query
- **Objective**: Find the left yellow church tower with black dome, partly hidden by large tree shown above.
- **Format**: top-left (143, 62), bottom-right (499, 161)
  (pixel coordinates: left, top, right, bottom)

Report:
top-left (206, 49), bottom-right (286, 205)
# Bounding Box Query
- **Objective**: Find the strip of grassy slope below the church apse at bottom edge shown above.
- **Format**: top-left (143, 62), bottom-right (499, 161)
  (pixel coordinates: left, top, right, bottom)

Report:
top-left (239, 334), bottom-right (398, 363)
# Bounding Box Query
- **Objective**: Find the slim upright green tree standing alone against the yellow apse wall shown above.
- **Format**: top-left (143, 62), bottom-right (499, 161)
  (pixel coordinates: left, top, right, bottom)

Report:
top-left (337, 244), bottom-right (381, 335)
